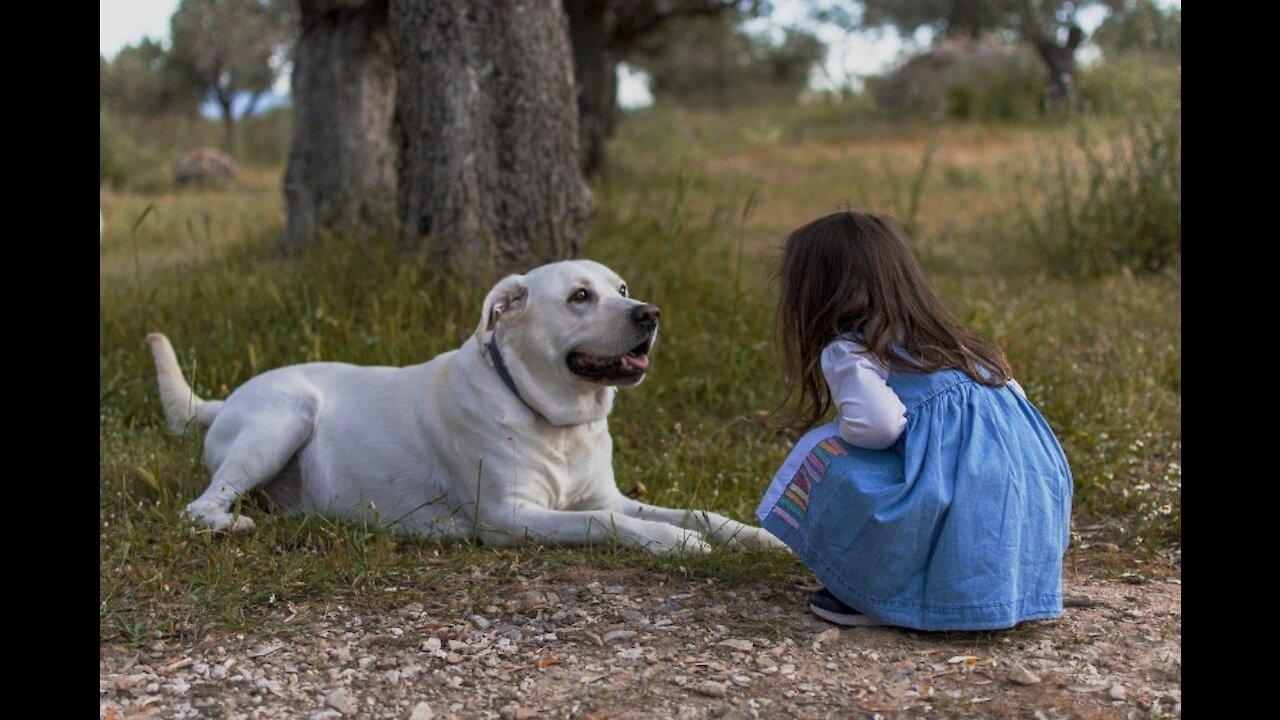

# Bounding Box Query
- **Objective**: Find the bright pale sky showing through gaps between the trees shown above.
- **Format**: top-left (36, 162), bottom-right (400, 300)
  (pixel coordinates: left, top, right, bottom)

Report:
top-left (99, 0), bottom-right (1183, 108)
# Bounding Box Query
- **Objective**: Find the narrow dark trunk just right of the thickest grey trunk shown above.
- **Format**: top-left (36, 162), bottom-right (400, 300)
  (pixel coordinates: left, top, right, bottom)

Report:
top-left (564, 0), bottom-right (618, 177)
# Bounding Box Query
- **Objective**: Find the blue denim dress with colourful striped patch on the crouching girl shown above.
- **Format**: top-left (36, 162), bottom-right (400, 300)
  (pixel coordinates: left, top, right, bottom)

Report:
top-left (756, 370), bottom-right (1073, 630)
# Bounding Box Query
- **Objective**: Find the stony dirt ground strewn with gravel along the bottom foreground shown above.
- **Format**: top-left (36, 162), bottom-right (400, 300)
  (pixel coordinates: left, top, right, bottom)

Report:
top-left (99, 545), bottom-right (1181, 720)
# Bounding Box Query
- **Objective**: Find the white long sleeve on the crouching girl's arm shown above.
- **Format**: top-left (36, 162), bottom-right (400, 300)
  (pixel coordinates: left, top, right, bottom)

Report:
top-left (822, 340), bottom-right (906, 450)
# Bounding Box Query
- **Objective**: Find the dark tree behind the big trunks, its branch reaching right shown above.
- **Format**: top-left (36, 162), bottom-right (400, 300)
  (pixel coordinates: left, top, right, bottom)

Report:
top-left (563, 0), bottom-right (767, 176)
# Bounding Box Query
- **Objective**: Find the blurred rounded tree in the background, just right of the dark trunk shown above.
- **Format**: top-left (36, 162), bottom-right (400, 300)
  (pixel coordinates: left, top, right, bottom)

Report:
top-left (632, 13), bottom-right (827, 106)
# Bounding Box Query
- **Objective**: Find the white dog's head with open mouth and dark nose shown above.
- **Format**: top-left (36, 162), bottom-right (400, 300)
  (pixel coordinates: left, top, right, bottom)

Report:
top-left (476, 260), bottom-right (659, 424)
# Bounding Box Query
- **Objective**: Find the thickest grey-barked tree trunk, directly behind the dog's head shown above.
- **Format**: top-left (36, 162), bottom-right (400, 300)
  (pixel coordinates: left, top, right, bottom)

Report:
top-left (390, 0), bottom-right (591, 269)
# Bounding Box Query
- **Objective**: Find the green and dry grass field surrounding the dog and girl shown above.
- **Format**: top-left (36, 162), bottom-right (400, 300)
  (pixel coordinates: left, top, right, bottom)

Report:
top-left (100, 106), bottom-right (1181, 643)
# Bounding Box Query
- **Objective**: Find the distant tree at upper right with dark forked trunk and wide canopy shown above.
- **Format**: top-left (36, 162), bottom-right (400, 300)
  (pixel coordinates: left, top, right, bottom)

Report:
top-left (815, 0), bottom-right (1125, 102)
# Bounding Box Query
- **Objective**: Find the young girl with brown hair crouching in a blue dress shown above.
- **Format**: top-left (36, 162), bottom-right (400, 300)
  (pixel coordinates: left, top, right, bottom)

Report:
top-left (756, 211), bottom-right (1073, 630)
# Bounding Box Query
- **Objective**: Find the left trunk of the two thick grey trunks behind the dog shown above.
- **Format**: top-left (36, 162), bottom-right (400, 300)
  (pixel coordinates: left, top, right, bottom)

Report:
top-left (282, 0), bottom-right (396, 250)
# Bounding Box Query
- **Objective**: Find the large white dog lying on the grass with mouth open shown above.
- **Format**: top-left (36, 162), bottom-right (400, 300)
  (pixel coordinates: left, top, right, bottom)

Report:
top-left (147, 260), bottom-right (783, 552)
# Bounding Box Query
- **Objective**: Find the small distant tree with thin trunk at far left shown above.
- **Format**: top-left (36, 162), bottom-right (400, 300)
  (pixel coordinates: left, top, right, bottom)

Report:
top-left (169, 0), bottom-right (297, 154)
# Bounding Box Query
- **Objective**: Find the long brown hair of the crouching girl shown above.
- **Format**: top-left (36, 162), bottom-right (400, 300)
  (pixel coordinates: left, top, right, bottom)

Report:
top-left (773, 210), bottom-right (1012, 429)
